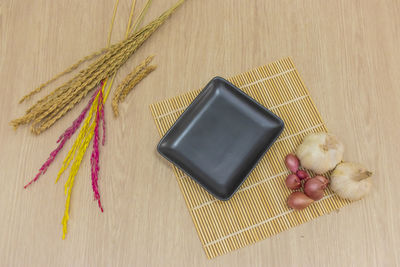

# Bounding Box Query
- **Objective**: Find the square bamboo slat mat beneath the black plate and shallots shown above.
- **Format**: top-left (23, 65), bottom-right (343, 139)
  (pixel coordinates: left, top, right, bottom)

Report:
top-left (150, 58), bottom-right (350, 258)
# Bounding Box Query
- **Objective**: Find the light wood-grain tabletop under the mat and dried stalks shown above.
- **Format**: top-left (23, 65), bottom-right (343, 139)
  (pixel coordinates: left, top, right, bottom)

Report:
top-left (0, 0), bottom-right (400, 266)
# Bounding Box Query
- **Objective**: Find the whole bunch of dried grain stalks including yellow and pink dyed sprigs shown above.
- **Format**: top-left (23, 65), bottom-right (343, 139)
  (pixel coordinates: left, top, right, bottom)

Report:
top-left (18, 0), bottom-right (185, 239)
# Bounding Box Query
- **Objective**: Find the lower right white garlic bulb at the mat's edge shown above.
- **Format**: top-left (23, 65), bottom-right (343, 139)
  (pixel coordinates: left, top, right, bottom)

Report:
top-left (331, 162), bottom-right (372, 200)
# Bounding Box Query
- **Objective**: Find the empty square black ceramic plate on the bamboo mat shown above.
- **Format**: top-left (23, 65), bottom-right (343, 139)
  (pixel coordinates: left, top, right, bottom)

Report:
top-left (157, 77), bottom-right (284, 200)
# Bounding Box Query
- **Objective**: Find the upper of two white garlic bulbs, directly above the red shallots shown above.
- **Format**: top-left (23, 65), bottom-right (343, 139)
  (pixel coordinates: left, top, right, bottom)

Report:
top-left (296, 132), bottom-right (344, 174)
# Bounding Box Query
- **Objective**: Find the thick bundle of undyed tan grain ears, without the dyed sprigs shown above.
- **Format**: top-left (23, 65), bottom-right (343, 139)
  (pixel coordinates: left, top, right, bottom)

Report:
top-left (11, 0), bottom-right (185, 134)
